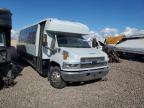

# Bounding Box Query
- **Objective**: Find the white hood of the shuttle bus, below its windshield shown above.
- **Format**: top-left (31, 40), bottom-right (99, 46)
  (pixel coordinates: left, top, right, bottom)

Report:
top-left (62, 48), bottom-right (106, 57)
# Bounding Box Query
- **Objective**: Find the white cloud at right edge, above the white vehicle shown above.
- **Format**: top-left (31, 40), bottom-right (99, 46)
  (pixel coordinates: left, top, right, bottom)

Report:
top-left (121, 27), bottom-right (144, 37)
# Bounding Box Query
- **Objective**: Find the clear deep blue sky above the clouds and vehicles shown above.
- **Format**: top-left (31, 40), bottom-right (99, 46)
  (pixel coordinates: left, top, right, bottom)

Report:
top-left (0, 0), bottom-right (144, 32)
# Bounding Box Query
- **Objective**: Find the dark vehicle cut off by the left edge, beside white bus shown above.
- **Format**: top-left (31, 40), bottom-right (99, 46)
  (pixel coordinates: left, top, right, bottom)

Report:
top-left (0, 8), bottom-right (12, 87)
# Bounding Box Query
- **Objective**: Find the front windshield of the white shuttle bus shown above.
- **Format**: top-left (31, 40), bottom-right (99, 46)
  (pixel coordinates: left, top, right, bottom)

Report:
top-left (57, 35), bottom-right (90, 48)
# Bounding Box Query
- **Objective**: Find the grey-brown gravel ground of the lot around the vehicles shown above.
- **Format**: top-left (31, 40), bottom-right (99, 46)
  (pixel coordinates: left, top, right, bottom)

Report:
top-left (0, 60), bottom-right (144, 108)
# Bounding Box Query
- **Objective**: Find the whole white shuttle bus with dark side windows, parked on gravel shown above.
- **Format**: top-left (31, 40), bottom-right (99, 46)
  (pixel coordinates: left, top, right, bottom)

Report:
top-left (17, 19), bottom-right (109, 89)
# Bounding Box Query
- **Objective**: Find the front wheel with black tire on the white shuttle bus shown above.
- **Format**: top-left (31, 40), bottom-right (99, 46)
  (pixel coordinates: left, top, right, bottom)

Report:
top-left (49, 66), bottom-right (66, 89)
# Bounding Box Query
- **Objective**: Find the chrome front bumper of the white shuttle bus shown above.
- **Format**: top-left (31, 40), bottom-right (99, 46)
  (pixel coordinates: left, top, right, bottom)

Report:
top-left (61, 67), bottom-right (109, 82)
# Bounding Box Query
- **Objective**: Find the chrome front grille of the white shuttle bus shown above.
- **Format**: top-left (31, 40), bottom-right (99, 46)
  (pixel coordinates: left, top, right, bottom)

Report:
top-left (80, 57), bottom-right (107, 68)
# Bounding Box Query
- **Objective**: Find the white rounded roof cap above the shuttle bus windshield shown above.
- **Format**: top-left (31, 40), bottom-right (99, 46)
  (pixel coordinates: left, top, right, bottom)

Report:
top-left (21, 18), bottom-right (89, 34)
